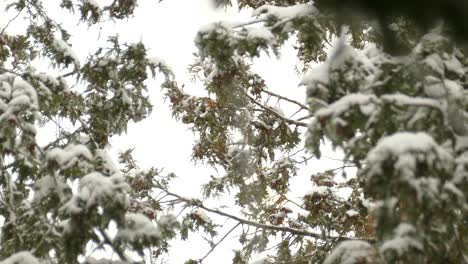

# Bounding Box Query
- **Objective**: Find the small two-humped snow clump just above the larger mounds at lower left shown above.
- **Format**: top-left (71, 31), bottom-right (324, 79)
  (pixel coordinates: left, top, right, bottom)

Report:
top-left (46, 144), bottom-right (93, 169)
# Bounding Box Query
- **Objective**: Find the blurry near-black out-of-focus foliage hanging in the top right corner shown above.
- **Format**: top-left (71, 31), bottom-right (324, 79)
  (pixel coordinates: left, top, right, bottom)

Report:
top-left (314, 0), bottom-right (468, 55)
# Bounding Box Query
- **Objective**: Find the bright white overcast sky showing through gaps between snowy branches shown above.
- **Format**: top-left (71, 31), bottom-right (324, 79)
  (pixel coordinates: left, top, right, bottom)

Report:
top-left (0, 0), bottom-right (348, 264)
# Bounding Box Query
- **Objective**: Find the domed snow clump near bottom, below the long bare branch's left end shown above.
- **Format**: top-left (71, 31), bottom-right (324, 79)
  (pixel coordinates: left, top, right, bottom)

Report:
top-left (116, 213), bottom-right (161, 242)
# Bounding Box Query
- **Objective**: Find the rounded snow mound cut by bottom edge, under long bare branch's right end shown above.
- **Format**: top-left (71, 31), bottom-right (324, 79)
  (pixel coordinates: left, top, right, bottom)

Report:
top-left (323, 240), bottom-right (379, 264)
